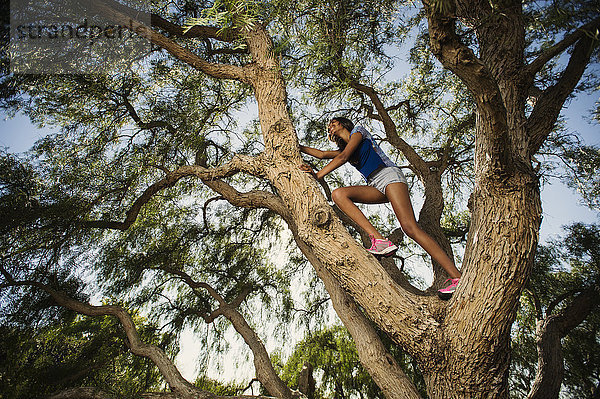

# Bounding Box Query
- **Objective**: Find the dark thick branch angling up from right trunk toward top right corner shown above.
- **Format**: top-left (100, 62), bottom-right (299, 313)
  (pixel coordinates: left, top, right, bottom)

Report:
top-left (526, 30), bottom-right (600, 155)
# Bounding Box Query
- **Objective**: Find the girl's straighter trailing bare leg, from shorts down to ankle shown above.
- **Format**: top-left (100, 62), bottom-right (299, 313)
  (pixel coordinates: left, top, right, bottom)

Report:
top-left (385, 183), bottom-right (460, 278)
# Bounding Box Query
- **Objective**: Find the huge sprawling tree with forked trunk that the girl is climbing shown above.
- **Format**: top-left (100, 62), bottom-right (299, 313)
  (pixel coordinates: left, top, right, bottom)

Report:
top-left (2, 1), bottom-right (600, 398)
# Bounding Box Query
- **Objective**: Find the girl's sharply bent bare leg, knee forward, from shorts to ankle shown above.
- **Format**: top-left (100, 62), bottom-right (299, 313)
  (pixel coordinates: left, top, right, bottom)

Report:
top-left (331, 186), bottom-right (388, 239)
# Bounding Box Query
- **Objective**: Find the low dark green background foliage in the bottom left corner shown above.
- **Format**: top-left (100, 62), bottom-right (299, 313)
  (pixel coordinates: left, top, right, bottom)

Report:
top-left (0, 316), bottom-right (168, 399)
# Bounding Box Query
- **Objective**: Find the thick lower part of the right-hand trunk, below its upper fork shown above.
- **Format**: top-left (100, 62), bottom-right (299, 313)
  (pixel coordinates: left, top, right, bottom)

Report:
top-left (428, 171), bottom-right (540, 398)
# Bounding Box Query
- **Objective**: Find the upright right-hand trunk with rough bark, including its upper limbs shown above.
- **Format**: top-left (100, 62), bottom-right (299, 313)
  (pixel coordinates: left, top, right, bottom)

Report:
top-left (426, 1), bottom-right (594, 398)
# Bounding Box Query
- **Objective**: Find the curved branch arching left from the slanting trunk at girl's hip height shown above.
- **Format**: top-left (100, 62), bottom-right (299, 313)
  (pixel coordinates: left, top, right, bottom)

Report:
top-left (84, 155), bottom-right (262, 230)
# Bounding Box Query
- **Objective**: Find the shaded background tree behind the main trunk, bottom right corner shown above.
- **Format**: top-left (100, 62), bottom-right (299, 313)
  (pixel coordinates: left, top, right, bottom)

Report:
top-left (513, 223), bottom-right (600, 398)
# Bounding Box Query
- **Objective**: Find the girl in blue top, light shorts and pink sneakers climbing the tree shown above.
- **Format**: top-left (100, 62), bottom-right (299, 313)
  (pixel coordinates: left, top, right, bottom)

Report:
top-left (300, 117), bottom-right (461, 299)
